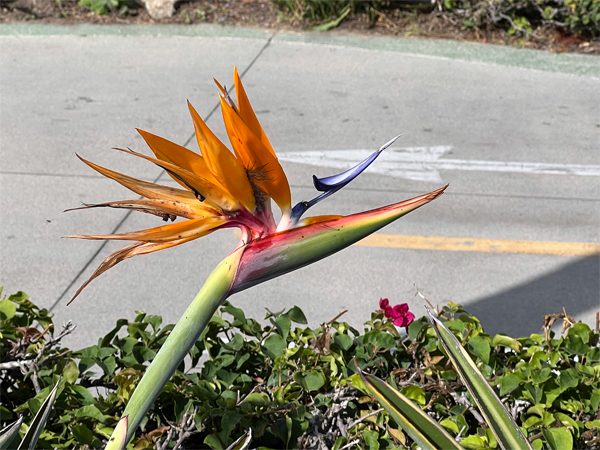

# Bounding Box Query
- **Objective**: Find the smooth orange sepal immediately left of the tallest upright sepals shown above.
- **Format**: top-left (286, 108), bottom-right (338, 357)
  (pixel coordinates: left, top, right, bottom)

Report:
top-left (188, 102), bottom-right (256, 213)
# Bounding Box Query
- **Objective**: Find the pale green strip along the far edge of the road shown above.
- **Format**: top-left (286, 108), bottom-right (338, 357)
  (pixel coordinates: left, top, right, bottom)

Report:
top-left (0, 23), bottom-right (600, 78)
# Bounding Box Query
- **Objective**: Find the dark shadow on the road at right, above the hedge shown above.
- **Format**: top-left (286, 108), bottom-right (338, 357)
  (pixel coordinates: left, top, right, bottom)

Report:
top-left (466, 256), bottom-right (600, 336)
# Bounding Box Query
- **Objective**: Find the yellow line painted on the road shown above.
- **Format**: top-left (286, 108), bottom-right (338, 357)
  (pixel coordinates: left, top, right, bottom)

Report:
top-left (354, 234), bottom-right (600, 256)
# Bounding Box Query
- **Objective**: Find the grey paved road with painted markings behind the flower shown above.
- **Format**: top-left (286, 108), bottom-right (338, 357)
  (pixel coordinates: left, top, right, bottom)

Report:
top-left (0, 25), bottom-right (600, 345)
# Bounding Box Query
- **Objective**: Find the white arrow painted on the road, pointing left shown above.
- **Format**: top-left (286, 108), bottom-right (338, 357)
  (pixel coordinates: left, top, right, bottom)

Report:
top-left (277, 145), bottom-right (600, 183)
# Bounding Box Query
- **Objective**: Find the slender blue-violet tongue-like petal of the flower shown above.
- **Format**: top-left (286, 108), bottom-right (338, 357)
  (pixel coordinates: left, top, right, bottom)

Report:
top-left (291, 135), bottom-right (401, 226)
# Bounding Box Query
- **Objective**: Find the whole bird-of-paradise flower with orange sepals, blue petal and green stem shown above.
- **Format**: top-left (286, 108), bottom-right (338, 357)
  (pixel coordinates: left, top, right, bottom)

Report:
top-left (69, 70), bottom-right (446, 441)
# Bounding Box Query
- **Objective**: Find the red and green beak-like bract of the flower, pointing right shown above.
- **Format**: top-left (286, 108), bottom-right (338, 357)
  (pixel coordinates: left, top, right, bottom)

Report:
top-left (232, 185), bottom-right (448, 293)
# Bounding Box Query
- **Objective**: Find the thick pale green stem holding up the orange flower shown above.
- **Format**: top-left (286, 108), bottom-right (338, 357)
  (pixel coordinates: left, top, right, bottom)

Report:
top-left (123, 249), bottom-right (242, 442)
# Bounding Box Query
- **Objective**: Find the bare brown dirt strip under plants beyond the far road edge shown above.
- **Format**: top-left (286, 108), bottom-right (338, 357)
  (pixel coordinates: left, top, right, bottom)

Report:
top-left (0, 0), bottom-right (600, 55)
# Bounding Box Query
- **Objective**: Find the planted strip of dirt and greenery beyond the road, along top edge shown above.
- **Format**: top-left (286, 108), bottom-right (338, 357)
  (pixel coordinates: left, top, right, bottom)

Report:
top-left (0, 0), bottom-right (600, 54)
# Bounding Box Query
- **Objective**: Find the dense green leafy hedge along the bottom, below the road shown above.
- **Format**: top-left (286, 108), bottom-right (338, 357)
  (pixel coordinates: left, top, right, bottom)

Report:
top-left (0, 292), bottom-right (600, 450)
